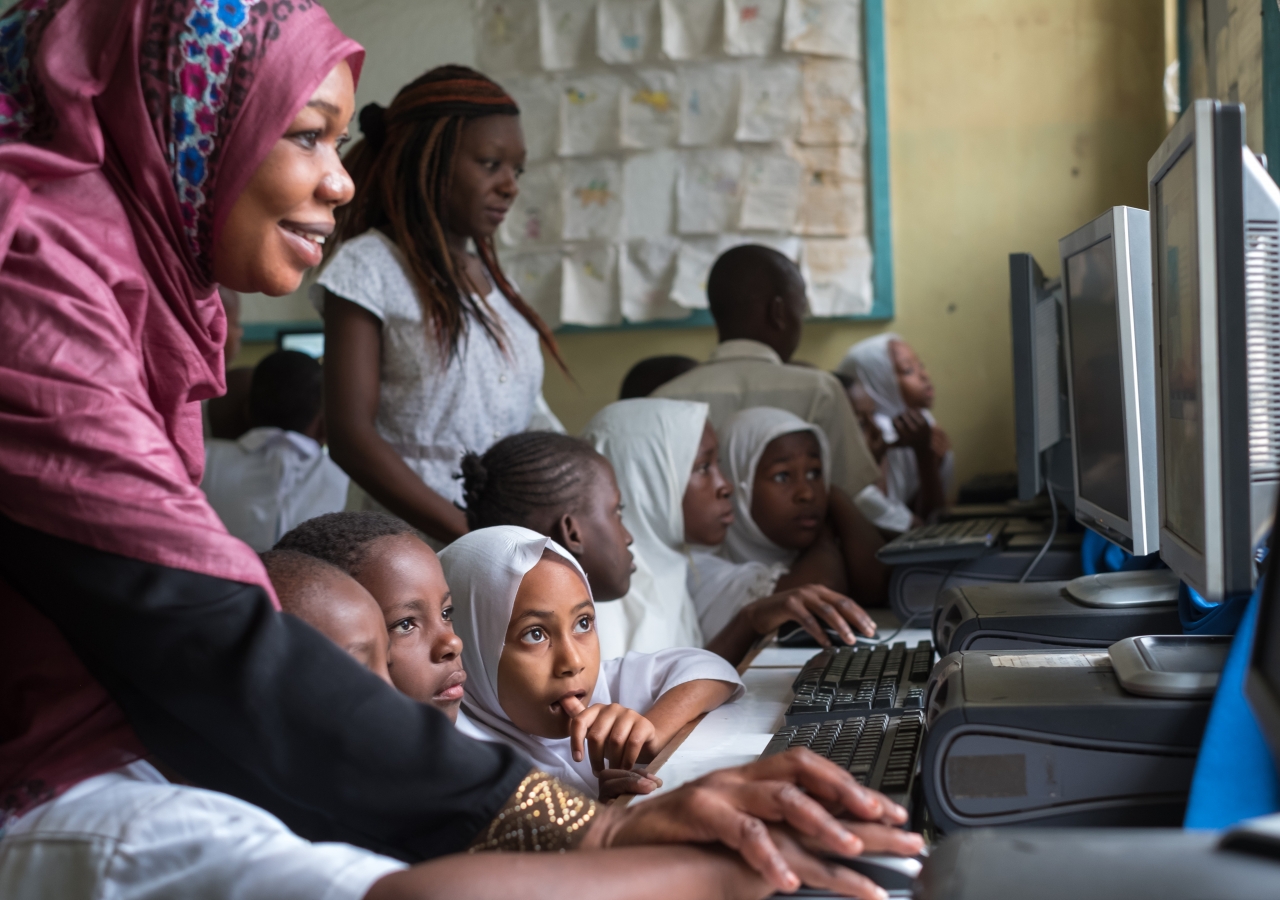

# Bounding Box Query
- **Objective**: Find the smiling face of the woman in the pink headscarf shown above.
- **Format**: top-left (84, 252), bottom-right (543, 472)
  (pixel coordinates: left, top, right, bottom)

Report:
top-left (212, 61), bottom-right (356, 297)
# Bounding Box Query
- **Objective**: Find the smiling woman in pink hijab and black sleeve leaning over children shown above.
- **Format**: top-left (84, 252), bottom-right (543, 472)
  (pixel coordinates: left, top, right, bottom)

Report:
top-left (0, 0), bottom-right (915, 897)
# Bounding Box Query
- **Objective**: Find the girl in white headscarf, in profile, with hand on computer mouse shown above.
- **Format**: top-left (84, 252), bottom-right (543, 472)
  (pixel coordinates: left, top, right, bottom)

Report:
top-left (582, 398), bottom-right (874, 663)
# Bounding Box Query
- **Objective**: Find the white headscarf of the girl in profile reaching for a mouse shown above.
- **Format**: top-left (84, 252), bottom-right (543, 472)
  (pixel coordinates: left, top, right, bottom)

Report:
top-left (582, 397), bottom-right (708, 658)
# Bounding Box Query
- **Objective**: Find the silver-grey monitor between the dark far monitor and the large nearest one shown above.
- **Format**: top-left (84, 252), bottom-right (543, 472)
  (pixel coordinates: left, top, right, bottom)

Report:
top-left (1059, 206), bottom-right (1160, 556)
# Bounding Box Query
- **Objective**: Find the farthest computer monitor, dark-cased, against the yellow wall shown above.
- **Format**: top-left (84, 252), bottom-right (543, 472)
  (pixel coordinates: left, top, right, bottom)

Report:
top-left (1009, 253), bottom-right (1071, 501)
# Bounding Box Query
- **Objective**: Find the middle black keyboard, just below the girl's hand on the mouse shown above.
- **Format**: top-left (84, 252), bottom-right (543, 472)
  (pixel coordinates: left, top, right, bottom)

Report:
top-left (783, 640), bottom-right (933, 725)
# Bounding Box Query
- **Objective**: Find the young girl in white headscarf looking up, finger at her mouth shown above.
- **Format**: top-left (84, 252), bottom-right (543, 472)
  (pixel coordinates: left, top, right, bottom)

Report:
top-left (440, 525), bottom-right (744, 799)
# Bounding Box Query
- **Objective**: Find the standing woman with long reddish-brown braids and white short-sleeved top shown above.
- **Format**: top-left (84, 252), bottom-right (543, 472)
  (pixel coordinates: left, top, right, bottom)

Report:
top-left (312, 65), bottom-right (564, 549)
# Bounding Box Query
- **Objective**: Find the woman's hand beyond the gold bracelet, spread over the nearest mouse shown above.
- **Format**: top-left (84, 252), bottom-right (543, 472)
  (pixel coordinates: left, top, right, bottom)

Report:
top-left (582, 750), bottom-right (923, 897)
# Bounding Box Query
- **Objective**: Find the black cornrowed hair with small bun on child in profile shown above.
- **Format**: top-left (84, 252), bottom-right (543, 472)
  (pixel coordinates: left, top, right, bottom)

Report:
top-left (462, 431), bottom-right (604, 534)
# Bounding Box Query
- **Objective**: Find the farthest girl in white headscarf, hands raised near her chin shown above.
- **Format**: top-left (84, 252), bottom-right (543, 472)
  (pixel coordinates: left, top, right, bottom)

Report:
top-left (838, 332), bottom-right (955, 529)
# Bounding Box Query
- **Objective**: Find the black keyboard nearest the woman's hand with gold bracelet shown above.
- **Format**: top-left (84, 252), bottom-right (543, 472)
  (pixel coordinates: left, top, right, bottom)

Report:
top-left (760, 709), bottom-right (924, 809)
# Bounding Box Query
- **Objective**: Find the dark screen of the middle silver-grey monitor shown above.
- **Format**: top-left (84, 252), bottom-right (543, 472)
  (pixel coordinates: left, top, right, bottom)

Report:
top-left (1066, 237), bottom-right (1129, 521)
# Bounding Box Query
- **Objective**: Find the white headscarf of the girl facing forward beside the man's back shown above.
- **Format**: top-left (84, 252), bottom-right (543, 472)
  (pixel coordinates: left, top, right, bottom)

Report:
top-left (721, 406), bottom-right (831, 566)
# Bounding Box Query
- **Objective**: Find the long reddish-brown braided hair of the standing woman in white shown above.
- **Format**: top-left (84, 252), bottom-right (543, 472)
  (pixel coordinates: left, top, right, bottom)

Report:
top-left (326, 65), bottom-right (568, 373)
